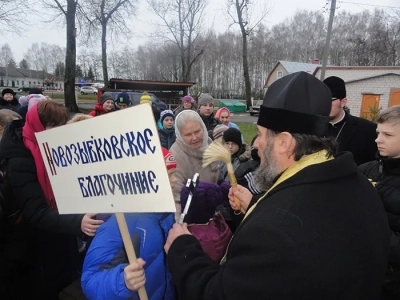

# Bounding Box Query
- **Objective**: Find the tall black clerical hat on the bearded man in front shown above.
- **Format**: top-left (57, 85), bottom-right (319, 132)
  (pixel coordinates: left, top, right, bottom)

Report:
top-left (257, 72), bottom-right (332, 137)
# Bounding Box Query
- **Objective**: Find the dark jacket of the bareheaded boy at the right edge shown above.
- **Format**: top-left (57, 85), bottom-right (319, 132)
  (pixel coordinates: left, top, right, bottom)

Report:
top-left (359, 157), bottom-right (400, 299)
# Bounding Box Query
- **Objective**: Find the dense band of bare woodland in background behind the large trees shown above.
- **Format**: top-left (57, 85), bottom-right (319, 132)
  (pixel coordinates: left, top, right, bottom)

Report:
top-left (72, 10), bottom-right (400, 98)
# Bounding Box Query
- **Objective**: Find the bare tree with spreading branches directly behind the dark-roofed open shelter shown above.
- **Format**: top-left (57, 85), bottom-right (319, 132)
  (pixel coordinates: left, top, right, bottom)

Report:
top-left (147, 0), bottom-right (207, 81)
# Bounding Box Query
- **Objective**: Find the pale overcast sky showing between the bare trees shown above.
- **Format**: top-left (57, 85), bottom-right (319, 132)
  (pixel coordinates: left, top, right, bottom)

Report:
top-left (0, 0), bottom-right (400, 63)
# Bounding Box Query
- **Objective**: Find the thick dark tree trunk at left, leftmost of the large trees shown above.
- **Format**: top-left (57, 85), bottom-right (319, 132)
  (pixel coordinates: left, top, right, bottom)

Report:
top-left (43, 0), bottom-right (79, 112)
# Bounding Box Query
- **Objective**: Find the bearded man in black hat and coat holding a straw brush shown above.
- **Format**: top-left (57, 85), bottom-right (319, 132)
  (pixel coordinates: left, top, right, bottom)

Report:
top-left (165, 72), bottom-right (390, 300)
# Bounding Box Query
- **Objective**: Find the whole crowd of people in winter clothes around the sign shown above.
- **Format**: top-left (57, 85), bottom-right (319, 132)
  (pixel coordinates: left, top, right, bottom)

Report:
top-left (0, 72), bottom-right (400, 300)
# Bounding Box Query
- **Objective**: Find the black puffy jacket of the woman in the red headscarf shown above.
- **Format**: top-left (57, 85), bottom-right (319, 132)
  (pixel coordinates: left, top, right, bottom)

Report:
top-left (0, 120), bottom-right (83, 299)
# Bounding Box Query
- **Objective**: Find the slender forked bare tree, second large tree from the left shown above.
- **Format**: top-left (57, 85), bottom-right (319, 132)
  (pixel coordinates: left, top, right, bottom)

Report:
top-left (81, 0), bottom-right (136, 86)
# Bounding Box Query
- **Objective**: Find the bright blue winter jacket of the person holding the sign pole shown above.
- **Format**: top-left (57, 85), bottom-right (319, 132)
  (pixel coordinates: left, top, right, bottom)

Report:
top-left (81, 213), bottom-right (175, 300)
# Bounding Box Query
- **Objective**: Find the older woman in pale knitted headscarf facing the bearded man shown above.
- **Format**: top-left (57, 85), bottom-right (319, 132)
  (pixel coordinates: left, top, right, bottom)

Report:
top-left (170, 110), bottom-right (219, 217)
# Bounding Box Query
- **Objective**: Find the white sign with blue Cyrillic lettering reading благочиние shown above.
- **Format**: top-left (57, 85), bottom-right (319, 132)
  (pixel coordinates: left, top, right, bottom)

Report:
top-left (36, 105), bottom-right (175, 214)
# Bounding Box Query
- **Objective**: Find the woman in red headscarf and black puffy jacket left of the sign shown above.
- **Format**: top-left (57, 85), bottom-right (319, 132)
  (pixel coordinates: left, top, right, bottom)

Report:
top-left (0, 100), bottom-right (103, 299)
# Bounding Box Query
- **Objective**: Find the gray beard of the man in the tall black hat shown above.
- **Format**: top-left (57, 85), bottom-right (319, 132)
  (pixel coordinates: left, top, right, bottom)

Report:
top-left (254, 143), bottom-right (281, 191)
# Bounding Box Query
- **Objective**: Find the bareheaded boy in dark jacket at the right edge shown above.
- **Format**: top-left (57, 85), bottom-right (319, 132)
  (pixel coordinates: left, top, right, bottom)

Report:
top-left (359, 105), bottom-right (400, 299)
